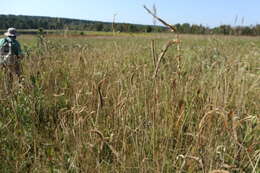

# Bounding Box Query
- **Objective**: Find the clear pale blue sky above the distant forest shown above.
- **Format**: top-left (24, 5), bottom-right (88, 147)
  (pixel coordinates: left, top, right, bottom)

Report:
top-left (0, 0), bottom-right (260, 27)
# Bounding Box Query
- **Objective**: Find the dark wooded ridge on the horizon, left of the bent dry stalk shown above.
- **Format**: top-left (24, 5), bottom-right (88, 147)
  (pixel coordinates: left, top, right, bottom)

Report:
top-left (0, 15), bottom-right (166, 32)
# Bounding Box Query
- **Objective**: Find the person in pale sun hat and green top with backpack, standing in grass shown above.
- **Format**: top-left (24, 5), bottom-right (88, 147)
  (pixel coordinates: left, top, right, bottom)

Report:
top-left (0, 28), bottom-right (23, 92)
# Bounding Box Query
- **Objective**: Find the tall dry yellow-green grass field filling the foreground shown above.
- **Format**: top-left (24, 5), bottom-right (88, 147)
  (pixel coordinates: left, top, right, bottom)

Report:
top-left (0, 33), bottom-right (260, 173)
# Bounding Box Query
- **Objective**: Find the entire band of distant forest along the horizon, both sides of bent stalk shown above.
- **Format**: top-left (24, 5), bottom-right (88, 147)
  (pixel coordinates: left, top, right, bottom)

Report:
top-left (0, 15), bottom-right (260, 36)
